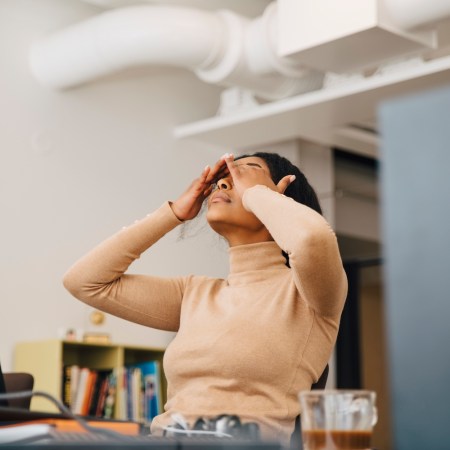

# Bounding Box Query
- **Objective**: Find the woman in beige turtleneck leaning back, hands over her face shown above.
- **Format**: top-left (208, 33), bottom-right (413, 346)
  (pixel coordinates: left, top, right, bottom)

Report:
top-left (64, 153), bottom-right (347, 445)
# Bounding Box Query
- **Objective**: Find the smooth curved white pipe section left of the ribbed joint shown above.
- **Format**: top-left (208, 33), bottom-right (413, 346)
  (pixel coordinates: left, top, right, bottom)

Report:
top-left (30, 6), bottom-right (224, 89)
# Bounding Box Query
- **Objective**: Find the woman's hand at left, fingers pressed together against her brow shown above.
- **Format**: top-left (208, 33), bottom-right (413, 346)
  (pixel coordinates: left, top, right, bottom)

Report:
top-left (170, 157), bottom-right (229, 221)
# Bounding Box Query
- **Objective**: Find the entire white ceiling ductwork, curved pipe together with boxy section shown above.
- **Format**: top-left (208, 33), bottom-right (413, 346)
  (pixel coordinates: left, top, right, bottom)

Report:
top-left (30, 0), bottom-right (450, 100)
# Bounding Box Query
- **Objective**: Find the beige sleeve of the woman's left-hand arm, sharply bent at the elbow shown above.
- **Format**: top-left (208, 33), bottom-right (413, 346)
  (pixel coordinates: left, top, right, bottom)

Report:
top-left (63, 203), bottom-right (186, 331)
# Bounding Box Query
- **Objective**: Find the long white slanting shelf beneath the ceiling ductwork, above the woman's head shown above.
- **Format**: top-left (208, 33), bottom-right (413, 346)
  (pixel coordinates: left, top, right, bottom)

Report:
top-left (174, 56), bottom-right (450, 156)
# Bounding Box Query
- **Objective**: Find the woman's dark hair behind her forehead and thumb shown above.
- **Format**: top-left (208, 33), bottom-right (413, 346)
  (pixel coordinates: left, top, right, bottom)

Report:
top-left (235, 152), bottom-right (322, 214)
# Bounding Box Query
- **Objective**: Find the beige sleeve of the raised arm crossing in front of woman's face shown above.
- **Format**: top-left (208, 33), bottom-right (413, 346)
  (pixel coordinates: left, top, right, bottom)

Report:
top-left (242, 185), bottom-right (347, 316)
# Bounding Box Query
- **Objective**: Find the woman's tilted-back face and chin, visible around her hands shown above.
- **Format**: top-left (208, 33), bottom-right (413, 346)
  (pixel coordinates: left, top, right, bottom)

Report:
top-left (206, 156), bottom-right (272, 246)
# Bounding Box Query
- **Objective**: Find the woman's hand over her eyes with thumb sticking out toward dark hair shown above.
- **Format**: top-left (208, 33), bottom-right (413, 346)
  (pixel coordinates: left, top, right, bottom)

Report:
top-left (224, 154), bottom-right (295, 198)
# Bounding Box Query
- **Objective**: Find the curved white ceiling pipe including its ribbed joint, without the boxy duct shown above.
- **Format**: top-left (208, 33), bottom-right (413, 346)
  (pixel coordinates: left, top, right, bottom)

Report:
top-left (30, 5), bottom-right (323, 100)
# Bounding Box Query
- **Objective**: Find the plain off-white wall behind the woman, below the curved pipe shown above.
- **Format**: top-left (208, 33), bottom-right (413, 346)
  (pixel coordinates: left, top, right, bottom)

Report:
top-left (0, 0), bottom-right (228, 370)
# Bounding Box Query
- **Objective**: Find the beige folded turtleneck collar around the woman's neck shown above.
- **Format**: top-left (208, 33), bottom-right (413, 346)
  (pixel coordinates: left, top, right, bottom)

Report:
top-left (228, 241), bottom-right (288, 284)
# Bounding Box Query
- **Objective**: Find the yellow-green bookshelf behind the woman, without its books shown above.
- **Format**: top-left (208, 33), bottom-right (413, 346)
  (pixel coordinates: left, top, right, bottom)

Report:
top-left (14, 339), bottom-right (167, 418)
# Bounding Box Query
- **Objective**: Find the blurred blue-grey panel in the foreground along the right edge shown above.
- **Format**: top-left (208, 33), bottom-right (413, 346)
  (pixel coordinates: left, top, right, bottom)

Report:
top-left (379, 81), bottom-right (450, 450)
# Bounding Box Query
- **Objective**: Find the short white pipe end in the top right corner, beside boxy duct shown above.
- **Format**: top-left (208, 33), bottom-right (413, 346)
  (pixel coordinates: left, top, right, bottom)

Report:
top-left (381, 0), bottom-right (450, 30)
